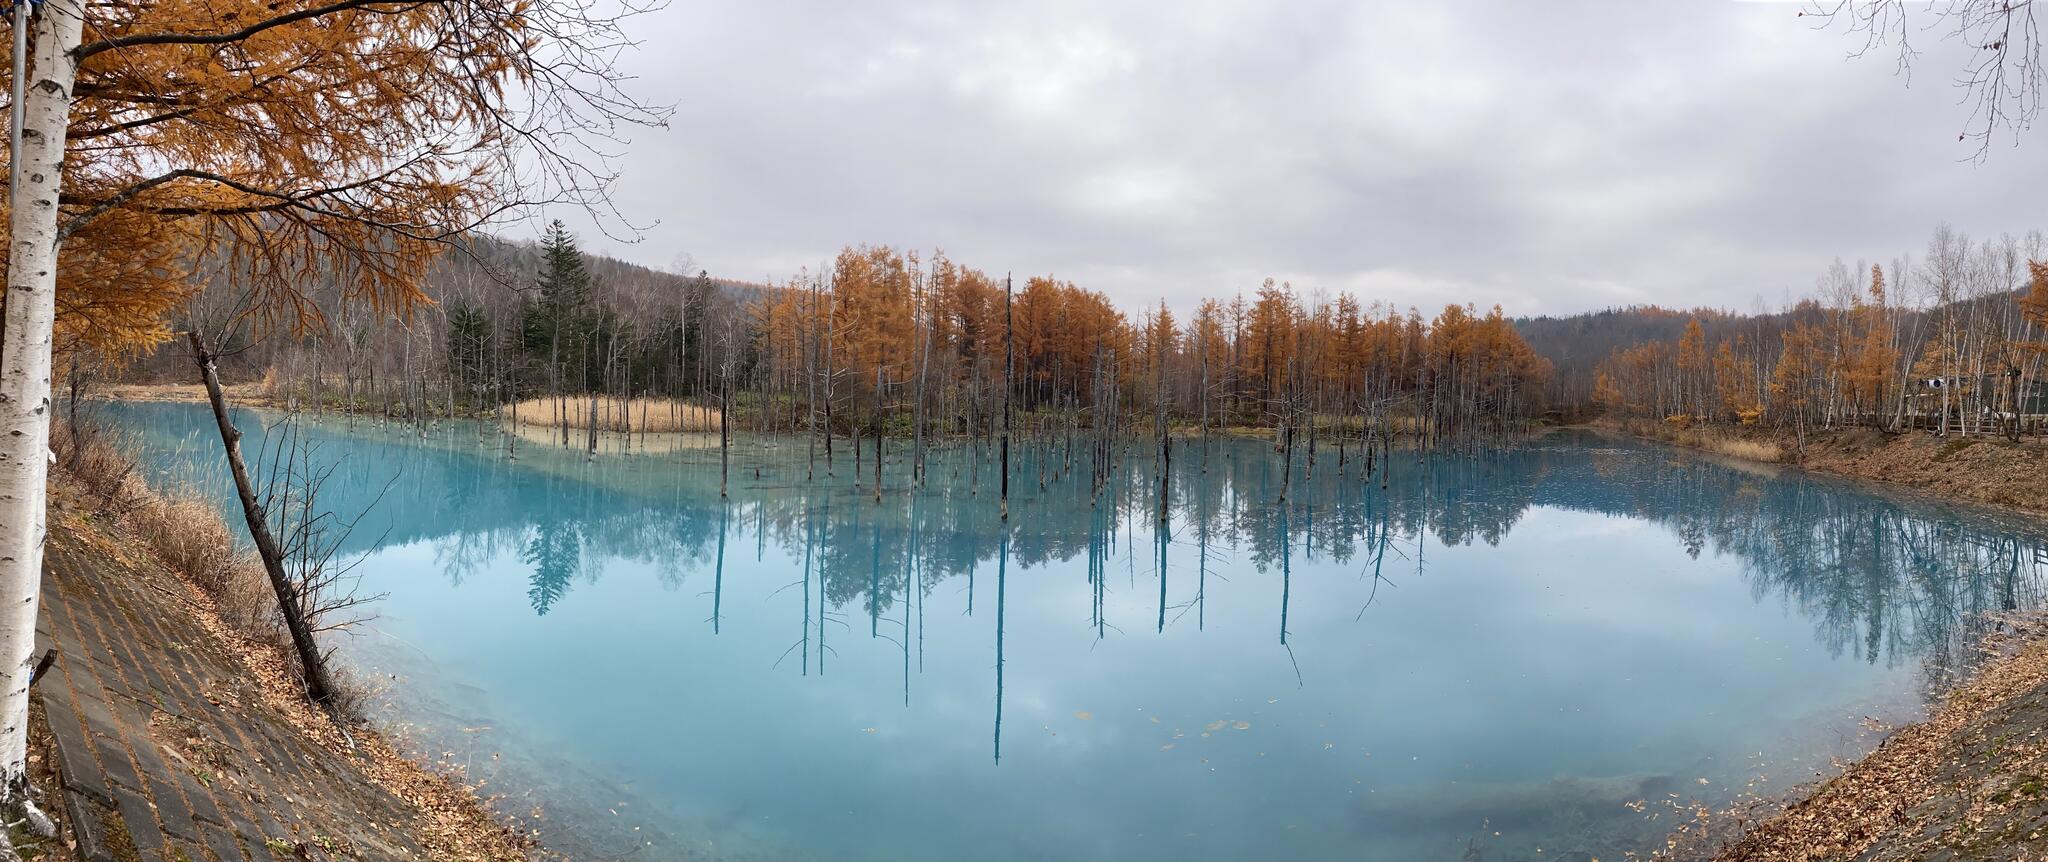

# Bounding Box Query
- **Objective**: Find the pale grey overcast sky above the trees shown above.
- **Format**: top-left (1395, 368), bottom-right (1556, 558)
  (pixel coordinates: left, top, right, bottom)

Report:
top-left (528, 0), bottom-right (2048, 313)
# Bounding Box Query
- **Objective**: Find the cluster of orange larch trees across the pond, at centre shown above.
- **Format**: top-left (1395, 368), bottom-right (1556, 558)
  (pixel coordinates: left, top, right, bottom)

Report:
top-left (754, 246), bottom-right (1550, 422)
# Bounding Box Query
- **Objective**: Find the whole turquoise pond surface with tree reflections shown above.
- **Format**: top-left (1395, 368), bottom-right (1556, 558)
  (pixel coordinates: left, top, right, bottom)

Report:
top-left (102, 403), bottom-right (2048, 860)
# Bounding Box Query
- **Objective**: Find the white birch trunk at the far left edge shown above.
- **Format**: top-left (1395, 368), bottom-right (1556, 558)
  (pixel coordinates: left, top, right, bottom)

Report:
top-left (0, 0), bottom-right (82, 805)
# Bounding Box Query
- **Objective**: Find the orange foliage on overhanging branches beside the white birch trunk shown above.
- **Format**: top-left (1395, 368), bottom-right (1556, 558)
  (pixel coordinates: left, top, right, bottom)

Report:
top-left (0, 0), bottom-right (606, 348)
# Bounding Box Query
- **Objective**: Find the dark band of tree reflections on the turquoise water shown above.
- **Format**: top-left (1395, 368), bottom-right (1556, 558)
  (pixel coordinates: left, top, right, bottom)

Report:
top-left (475, 434), bottom-right (2048, 680)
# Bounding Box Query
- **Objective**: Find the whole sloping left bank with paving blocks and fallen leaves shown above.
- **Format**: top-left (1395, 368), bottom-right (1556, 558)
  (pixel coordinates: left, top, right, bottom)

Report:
top-left (31, 442), bottom-right (551, 862)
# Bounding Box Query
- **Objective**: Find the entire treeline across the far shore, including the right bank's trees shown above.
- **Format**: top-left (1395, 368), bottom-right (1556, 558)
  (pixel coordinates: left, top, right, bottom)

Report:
top-left (128, 223), bottom-right (2048, 452)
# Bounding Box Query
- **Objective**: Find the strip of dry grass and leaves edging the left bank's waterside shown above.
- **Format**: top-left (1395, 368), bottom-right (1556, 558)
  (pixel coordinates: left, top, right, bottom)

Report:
top-left (49, 425), bottom-right (537, 862)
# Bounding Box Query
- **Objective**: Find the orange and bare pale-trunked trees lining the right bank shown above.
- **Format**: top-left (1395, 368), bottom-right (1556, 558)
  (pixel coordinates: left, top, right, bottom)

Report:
top-left (1518, 225), bottom-right (2048, 434)
